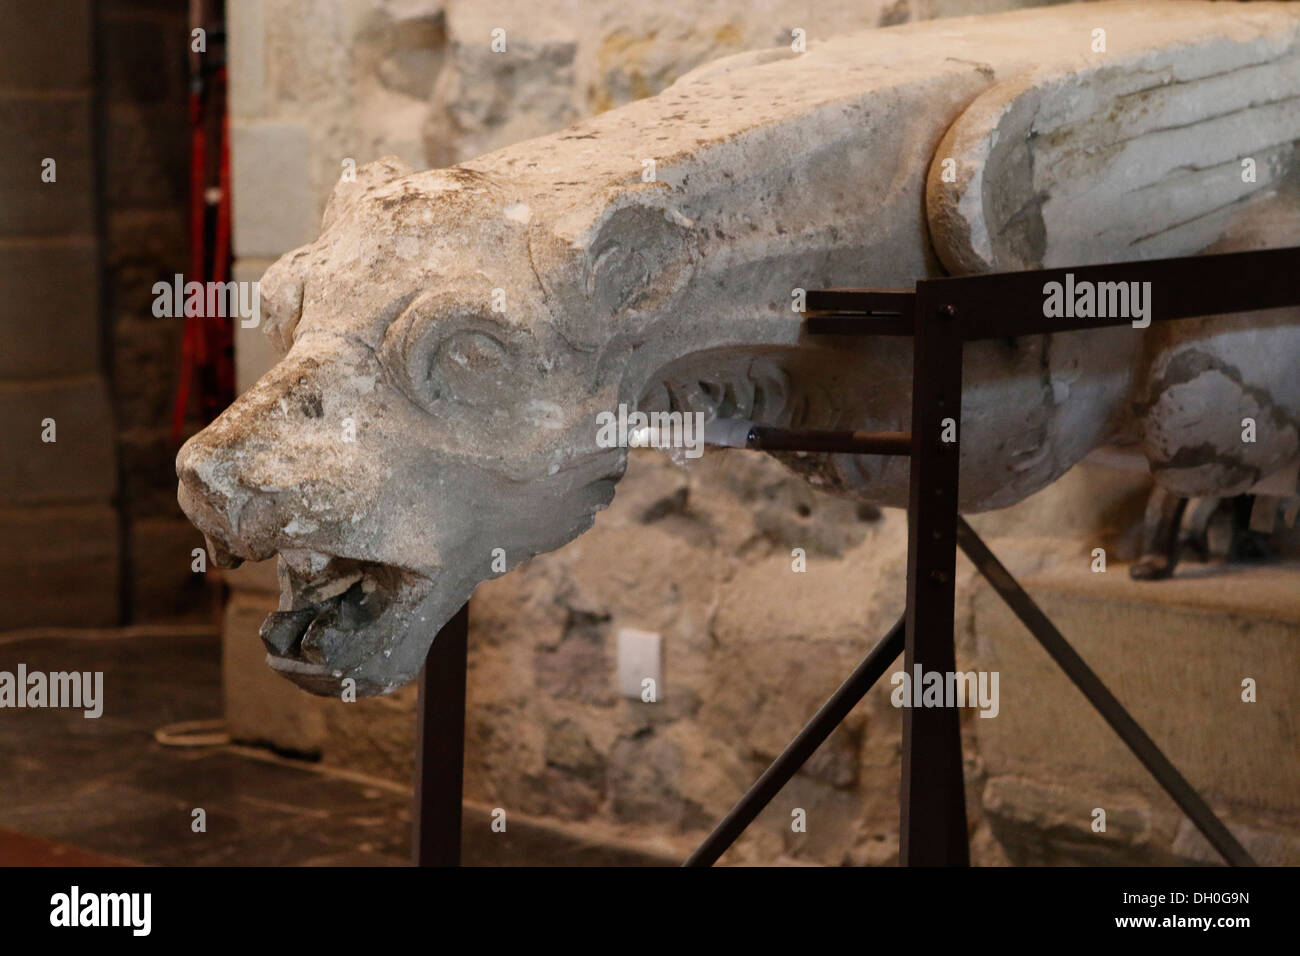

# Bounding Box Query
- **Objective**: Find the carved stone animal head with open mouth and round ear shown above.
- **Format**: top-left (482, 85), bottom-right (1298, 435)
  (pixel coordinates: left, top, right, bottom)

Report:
top-left (177, 159), bottom-right (702, 696)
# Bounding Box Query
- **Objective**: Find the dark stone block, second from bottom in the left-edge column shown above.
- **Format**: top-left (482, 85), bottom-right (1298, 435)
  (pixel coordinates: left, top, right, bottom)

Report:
top-left (0, 376), bottom-right (117, 506)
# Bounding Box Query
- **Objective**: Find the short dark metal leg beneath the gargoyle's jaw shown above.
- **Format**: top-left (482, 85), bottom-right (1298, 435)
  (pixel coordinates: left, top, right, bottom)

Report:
top-left (411, 604), bottom-right (469, 866)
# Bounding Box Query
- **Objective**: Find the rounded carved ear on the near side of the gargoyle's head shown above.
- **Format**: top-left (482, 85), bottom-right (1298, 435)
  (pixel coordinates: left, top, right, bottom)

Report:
top-left (533, 193), bottom-right (697, 341)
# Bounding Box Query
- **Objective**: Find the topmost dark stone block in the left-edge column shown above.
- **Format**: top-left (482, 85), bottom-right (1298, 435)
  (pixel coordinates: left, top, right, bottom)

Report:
top-left (0, 0), bottom-right (91, 90)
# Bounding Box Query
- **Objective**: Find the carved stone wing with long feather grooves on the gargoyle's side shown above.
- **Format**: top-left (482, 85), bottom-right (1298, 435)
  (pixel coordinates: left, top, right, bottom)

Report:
top-left (926, 43), bottom-right (1300, 273)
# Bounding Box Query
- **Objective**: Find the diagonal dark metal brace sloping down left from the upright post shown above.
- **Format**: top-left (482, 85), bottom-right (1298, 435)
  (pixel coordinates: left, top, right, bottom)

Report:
top-left (683, 619), bottom-right (904, 866)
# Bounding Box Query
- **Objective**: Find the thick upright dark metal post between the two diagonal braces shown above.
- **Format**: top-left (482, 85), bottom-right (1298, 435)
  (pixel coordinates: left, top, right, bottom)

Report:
top-left (898, 282), bottom-right (970, 866)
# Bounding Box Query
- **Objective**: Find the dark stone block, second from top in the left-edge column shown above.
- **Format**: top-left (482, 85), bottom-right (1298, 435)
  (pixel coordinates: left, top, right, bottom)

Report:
top-left (0, 94), bottom-right (95, 235)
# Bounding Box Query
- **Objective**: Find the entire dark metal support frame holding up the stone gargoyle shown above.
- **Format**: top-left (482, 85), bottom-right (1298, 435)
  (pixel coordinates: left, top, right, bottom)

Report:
top-left (415, 246), bottom-right (1300, 866)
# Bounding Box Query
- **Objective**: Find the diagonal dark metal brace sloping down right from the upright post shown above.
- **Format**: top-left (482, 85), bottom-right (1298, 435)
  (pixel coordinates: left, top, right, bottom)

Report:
top-left (957, 520), bottom-right (1255, 866)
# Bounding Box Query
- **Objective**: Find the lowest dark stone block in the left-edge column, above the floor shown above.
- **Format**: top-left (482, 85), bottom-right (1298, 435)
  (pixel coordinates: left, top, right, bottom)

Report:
top-left (0, 505), bottom-right (120, 630)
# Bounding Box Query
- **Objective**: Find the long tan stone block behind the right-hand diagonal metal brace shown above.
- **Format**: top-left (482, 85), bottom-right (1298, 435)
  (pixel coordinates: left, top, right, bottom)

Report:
top-left (965, 549), bottom-right (1300, 862)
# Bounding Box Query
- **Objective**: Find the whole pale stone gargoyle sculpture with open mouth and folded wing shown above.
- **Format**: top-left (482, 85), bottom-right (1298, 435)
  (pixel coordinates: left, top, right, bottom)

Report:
top-left (177, 3), bottom-right (1300, 695)
